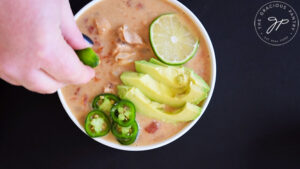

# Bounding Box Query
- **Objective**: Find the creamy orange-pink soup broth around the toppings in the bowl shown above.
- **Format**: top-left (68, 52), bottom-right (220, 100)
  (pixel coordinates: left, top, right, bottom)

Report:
top-left (62, 0), bottom-right (211, 146)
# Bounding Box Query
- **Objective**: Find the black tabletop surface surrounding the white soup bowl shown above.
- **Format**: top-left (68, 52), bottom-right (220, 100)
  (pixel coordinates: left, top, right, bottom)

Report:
top-left (0, 0), bottom-right (300, 169)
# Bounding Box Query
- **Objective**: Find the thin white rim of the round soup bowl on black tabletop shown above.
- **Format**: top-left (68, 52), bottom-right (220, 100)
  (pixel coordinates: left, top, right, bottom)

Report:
top-left (58, 0), bottom-right (216, 151)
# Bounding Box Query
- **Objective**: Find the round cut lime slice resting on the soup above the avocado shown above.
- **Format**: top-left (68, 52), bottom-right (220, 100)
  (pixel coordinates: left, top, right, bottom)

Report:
top-left (149, 13), bottom-right (199, 65)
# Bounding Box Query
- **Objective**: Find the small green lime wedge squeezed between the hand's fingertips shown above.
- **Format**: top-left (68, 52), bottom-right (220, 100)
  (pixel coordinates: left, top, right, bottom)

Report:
top-left (75, 48), bottom-right (100, 68)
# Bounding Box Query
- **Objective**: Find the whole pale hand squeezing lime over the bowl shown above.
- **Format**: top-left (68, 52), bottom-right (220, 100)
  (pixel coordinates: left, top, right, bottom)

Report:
top-left (0, 0), bottom-right (95, 93)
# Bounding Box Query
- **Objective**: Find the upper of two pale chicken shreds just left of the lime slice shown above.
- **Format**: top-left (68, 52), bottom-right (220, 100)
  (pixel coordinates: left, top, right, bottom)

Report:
top-left (118, 25), bottom-right (143, 45)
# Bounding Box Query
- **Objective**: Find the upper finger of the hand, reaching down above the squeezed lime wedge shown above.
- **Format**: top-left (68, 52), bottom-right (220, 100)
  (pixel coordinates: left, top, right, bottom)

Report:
top-left (60, 0), bottom-right (88, 49)
